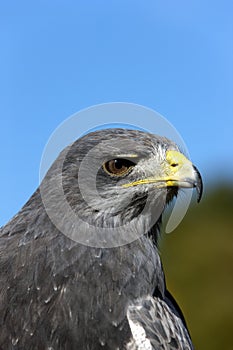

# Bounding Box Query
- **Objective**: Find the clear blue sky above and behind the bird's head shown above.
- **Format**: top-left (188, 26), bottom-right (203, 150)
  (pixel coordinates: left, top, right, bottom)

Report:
top-left (0, 0), bottom-right (233, 225)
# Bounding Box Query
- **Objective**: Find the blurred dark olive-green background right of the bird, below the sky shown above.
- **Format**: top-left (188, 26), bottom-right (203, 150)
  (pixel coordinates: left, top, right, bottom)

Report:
top-left (161, 183), bottom-right (233, 350)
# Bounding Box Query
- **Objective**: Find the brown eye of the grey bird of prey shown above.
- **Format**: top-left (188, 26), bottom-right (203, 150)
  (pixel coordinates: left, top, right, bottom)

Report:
top-left (103, 158), bottom-right (135, 176)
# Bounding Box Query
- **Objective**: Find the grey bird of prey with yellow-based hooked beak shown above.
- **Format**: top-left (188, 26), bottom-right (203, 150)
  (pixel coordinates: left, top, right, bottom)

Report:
top-left (0, 128), bottom-right (202, 350)
